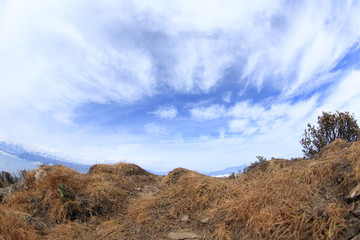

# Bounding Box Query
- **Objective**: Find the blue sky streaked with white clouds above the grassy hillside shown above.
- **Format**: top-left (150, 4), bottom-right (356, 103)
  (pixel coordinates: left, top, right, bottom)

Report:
top-left (0, 0), bottom-right (360, 171)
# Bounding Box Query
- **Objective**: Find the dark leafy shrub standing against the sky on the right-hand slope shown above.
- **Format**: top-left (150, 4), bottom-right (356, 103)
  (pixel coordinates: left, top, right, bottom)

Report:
top-left (300, 111), bottom-right (360, 158)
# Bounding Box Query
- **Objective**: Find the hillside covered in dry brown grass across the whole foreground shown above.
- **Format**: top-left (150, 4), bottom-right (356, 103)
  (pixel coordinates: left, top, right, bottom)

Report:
top-left (0, 140), bottom-right (360, 240)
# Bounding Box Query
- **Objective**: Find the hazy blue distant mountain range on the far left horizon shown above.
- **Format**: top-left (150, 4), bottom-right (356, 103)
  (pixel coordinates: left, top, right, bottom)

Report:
top-left (0, 141), bottom-right (91, 173)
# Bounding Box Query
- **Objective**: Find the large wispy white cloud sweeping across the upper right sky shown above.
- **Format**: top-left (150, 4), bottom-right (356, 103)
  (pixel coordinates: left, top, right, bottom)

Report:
top-left (136, 0), bottom-right (360, 95)
